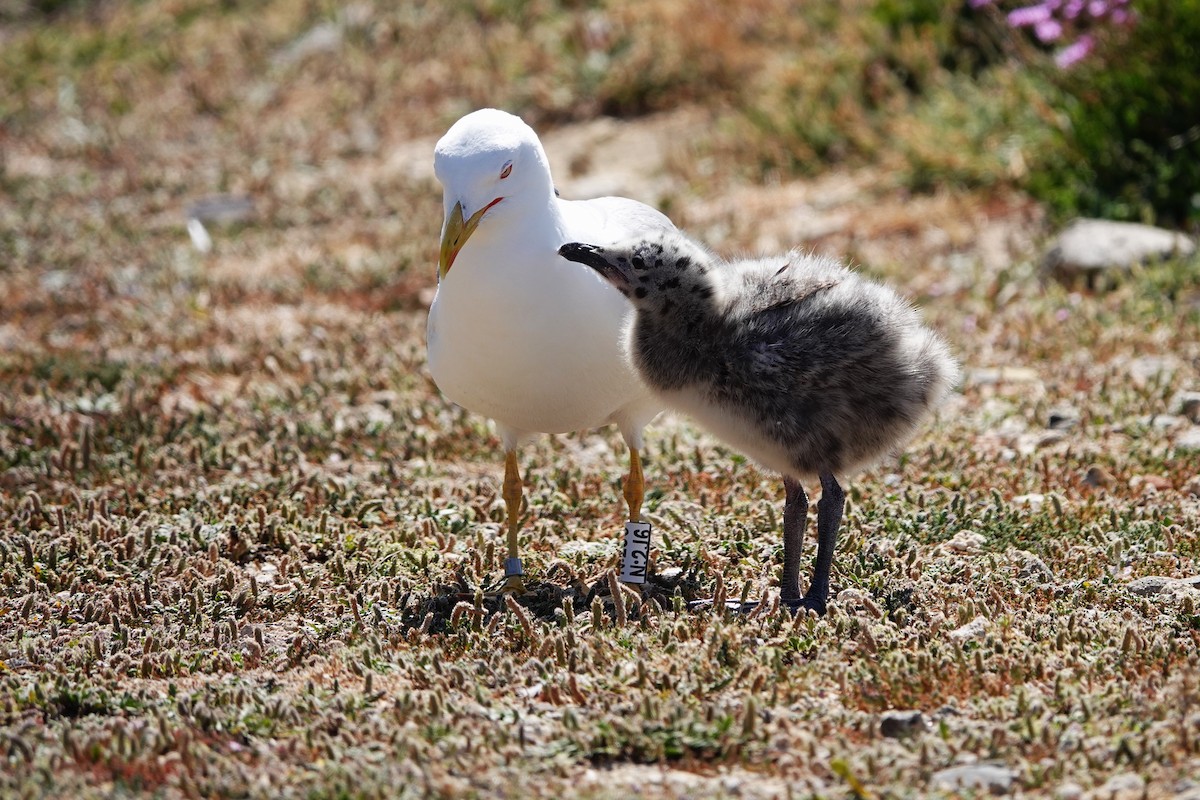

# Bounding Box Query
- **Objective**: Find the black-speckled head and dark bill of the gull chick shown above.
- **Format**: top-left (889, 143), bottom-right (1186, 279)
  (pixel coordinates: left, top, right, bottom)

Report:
top-left (558, 233), bottom-right (718, 318)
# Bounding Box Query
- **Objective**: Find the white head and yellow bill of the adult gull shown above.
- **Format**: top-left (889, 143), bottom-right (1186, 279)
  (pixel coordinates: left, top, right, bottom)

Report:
top-left (433, 108), bottom-right (554, 281)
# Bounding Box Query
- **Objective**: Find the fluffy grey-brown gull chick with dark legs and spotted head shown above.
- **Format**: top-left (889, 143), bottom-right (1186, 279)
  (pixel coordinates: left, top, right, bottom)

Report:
top-left (559, 233), bottom-right (958, 614)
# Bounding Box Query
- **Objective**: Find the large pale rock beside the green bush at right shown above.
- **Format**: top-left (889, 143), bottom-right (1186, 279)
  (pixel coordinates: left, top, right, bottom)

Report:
top-left (1044, 219), bottom-right (1195, 278)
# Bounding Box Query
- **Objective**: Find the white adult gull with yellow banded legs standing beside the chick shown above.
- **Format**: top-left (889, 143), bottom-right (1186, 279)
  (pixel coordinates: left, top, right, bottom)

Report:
top-left (427, 108), bottom-right (674, 591)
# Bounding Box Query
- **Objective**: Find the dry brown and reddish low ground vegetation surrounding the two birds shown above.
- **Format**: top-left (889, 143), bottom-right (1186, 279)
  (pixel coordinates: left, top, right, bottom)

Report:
top-left (0, 2), bottom-right (1200, 798)
